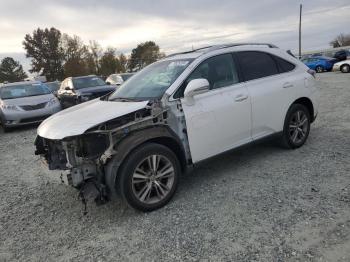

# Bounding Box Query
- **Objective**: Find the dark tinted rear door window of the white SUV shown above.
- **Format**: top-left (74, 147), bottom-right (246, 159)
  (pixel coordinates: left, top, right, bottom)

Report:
top-left (236, 51), bottom-right (279, 81)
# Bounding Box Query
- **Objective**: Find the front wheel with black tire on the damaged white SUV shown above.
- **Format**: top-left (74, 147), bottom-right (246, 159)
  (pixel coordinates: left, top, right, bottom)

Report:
top-left (117, 143), bottom-right (181, 212)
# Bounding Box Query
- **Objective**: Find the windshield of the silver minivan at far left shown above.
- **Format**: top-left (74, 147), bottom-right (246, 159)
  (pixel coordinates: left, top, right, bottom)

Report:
top-left (0, 83), bottom-right (51, 99)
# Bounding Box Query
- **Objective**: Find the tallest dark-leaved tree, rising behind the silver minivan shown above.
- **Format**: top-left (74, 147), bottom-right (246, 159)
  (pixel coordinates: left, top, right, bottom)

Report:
top-left (23, 27), bottom-right (64, 81)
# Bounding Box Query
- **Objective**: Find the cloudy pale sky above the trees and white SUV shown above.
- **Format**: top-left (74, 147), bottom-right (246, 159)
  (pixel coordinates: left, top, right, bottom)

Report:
top-left (0, 0), bottom-right (350, 70)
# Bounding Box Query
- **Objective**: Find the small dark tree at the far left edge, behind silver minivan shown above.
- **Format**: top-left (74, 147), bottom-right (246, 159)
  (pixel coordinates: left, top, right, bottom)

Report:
top-left (0, 57), bottom-right (28, 82)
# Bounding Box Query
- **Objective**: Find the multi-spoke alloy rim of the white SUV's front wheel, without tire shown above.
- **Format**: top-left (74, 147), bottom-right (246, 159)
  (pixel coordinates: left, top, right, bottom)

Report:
top-left (132, 154), bottom-right (175, 204)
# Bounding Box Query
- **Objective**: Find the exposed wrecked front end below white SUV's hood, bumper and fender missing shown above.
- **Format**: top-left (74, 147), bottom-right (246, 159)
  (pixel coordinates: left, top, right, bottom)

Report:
top-left (35, 103), bottom-right (182, 211)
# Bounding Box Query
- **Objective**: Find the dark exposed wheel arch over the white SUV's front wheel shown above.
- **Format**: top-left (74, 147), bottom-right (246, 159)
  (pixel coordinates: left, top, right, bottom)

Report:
top-left (104, 126), bottom-right (187, 197)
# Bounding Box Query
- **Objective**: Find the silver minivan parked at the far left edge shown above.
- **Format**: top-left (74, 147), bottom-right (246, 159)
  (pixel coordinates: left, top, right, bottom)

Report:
top-left (0, 81), bottom-right (61, 131)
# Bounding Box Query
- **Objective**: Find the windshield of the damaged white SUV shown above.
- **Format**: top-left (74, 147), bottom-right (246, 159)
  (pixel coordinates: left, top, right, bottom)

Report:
top-left (109, 59), bottom-right (193, 100)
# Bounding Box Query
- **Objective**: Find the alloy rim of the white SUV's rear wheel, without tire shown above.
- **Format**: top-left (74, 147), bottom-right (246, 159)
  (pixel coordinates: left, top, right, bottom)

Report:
top-left (289, 110), bottom-right (309, 144)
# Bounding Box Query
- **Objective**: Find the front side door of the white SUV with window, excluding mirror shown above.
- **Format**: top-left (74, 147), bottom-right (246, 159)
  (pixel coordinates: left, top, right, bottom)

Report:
top-left (181, 54), bottom-right (251, 163)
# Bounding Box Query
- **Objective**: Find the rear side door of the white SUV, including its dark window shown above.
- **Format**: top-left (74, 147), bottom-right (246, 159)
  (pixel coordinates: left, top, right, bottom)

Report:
top-left (235, 51), bottom-right (303, 140)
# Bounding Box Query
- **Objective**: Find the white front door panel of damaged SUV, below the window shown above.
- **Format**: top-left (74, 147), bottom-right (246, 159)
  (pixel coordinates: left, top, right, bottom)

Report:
top-left (181, 83), bottom-right (251, 163)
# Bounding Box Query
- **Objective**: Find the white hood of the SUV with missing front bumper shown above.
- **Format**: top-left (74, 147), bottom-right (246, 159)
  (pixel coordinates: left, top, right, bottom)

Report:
top-left (38, 99), bottom-right (148, 139)
